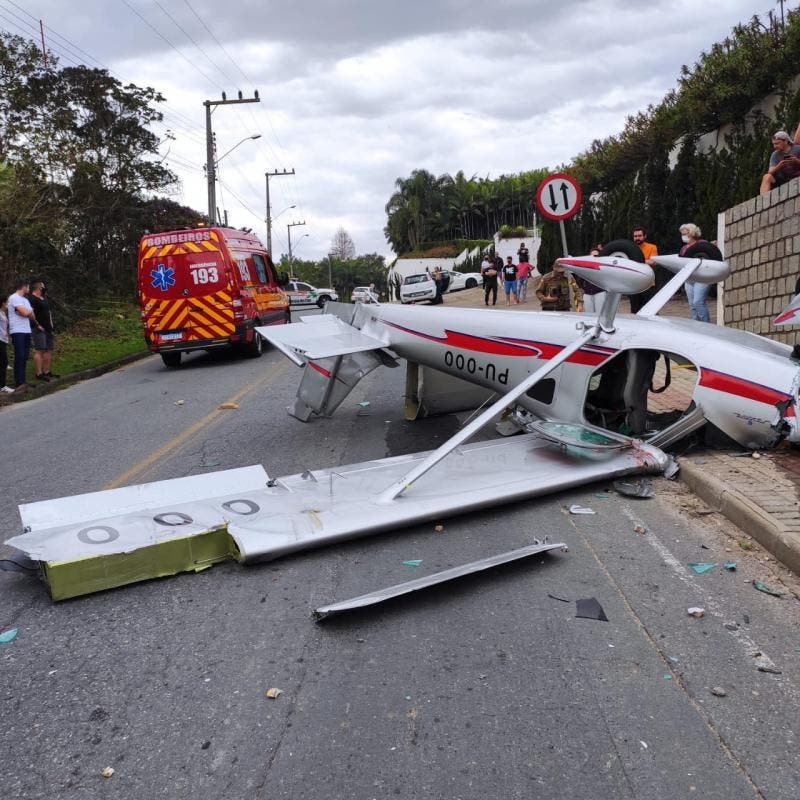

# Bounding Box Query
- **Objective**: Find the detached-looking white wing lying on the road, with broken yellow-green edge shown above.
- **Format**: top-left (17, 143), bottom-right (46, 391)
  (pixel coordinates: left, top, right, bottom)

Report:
top-left (7, 432), bottom-right (668, 600)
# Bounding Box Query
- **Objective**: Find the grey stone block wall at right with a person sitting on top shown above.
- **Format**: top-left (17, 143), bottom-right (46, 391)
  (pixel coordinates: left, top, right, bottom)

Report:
top-left (720, 178), bottom-right (800, 345)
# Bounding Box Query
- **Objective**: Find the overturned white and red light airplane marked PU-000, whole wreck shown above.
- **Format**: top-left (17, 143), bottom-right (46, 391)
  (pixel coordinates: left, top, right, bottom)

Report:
top-left (8, 255), bottom-right (800, 600)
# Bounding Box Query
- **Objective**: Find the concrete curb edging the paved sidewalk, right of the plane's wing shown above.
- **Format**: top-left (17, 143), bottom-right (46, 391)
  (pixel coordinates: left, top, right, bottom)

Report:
top-left (680, 459), bottom-right (800, 574)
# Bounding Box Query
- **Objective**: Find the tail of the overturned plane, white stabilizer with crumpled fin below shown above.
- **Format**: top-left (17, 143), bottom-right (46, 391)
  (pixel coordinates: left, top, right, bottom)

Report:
top-left (256, 303), bottom-right (397, 422)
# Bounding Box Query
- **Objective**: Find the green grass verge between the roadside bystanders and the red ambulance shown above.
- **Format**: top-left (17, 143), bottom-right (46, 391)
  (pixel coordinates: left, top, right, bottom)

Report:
top-left (7, 303), bottom-right (146, 383)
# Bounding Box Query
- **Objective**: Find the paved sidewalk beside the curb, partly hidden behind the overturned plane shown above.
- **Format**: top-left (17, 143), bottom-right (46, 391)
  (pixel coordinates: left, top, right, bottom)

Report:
top-left (445, 289), bottom-right (800, 575)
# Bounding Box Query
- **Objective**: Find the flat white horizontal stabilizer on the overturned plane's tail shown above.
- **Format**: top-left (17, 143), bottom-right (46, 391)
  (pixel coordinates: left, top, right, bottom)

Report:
top-left (256, 314), bottom-right (386, 361)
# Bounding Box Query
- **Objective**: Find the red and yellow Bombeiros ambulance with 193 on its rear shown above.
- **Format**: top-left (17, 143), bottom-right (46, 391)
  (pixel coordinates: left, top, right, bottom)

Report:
top-left (138, 228), bottom-right (290, 367)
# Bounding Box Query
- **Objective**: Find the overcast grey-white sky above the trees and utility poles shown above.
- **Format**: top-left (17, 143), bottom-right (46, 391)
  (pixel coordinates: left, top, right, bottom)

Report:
top-left (0, 0), bottom-right (774, 259)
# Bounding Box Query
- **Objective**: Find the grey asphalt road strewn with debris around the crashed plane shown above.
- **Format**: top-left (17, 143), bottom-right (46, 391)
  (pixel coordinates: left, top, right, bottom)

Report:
top-left (0, 314), bottom-right (800, 800)
